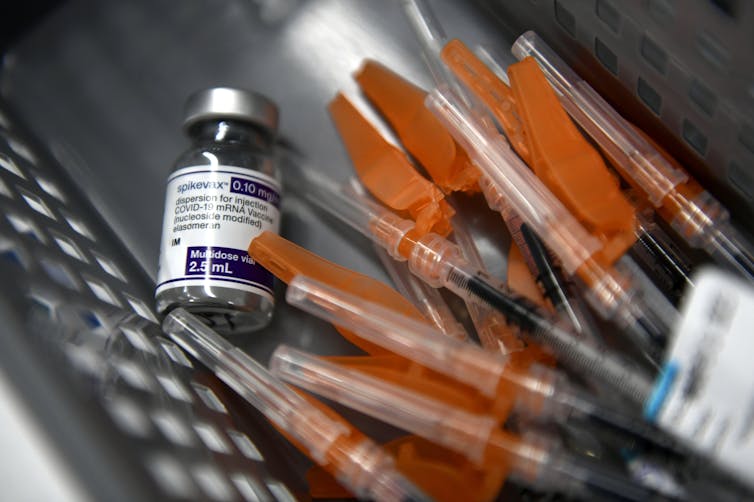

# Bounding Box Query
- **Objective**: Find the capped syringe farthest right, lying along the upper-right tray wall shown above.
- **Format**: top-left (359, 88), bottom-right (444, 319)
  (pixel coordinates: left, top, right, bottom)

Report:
top-left (512, 31), bottom-right (754, 280)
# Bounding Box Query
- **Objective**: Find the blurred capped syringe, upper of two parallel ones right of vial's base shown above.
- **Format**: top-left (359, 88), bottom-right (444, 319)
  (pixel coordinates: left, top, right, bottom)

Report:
top-left (286, 276), bottom-right (656, 439)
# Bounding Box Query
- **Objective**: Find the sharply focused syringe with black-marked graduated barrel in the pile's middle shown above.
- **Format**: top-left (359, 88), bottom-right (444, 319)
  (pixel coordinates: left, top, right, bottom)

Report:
top-left (290, 168), bottom-right (648, 389)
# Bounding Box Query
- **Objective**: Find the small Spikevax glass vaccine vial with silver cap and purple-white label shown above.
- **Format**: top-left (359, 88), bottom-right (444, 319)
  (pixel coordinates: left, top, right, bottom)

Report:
top-left (155, 87), bottom-right (280, 335)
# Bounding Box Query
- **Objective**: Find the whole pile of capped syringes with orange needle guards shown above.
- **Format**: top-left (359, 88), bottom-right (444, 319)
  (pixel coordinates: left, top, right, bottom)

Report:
top-left (163, 0), bottom-right (754, 500)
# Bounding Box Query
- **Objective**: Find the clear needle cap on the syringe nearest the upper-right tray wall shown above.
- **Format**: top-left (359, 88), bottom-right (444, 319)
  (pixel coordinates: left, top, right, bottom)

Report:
top-left (511, 31), bottom-right (688, 207)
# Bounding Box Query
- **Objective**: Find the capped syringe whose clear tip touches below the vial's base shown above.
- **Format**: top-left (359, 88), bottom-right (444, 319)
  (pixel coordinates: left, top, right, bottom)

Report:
top-left (162, 308), bottom-right (431, 501)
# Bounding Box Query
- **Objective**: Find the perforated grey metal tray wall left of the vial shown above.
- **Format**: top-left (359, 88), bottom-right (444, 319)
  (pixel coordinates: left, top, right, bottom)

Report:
top-left (0, 102), bottom-right (294, 501)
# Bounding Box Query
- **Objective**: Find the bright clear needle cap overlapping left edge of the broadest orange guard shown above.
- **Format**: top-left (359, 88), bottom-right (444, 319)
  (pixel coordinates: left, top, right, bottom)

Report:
top-left (427, 89), bottom-right (602, 274)
